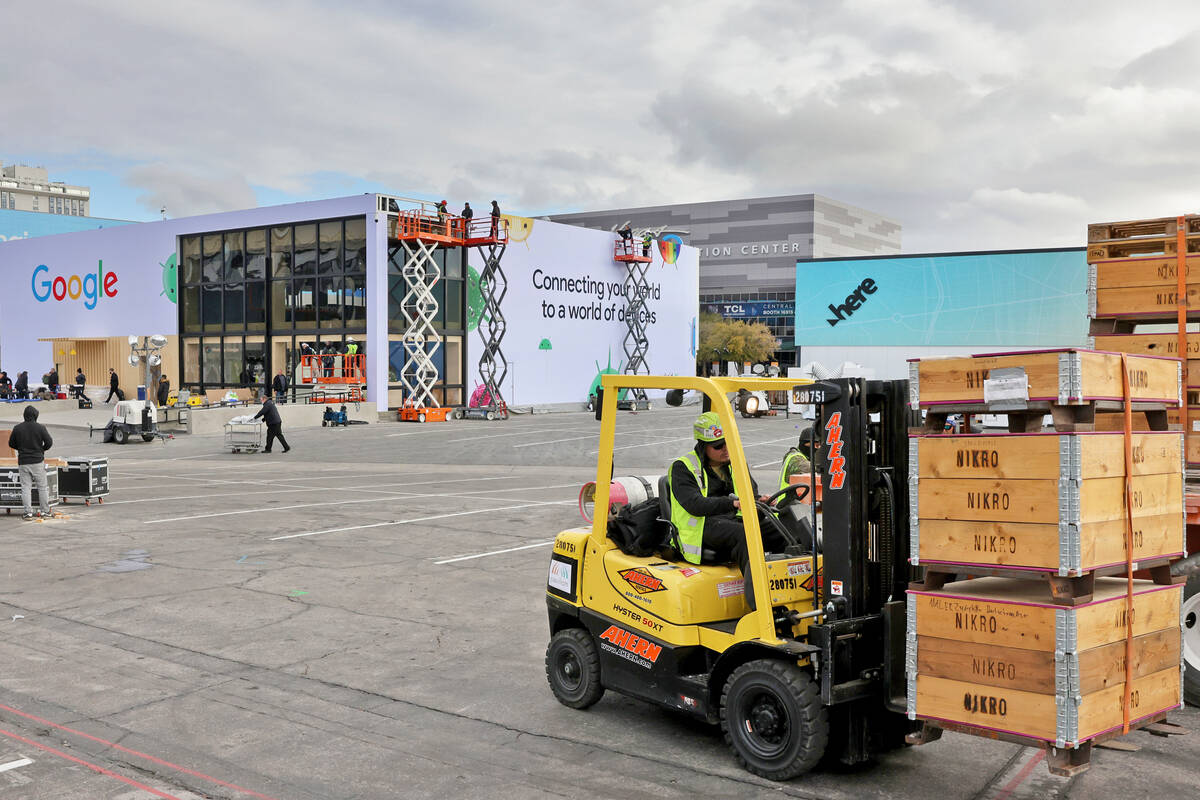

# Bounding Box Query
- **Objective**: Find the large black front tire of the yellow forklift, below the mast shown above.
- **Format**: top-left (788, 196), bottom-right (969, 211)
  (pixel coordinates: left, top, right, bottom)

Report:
top-left (721, 658), bottom-right (829, 781)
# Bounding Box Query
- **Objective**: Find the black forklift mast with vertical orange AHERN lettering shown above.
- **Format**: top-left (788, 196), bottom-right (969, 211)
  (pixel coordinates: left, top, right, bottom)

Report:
top-left (800, 378), bottom-right (912, 764)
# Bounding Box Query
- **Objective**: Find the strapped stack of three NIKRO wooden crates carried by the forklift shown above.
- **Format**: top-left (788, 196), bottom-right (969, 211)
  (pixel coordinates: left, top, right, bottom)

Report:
top-left (907, 350), bottom-right (1184, 774)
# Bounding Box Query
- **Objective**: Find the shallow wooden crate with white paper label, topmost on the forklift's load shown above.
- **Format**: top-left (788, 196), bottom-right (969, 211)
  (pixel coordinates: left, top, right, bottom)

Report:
top-left (908, 349), bottom-right (1181, 410)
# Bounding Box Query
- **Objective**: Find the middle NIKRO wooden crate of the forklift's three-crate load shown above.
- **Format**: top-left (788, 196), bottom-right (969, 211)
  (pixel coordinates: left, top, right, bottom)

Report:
top-left (908, 434), bottom-right (1184, 576)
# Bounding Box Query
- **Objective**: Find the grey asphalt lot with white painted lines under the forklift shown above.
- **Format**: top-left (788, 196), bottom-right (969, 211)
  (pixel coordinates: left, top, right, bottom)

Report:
top-left (0, 409), bottom-right (1200, 800)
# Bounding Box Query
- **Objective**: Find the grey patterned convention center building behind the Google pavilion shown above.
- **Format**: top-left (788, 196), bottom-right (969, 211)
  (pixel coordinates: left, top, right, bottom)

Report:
top-left (550, 194), bottom-right (900, 363)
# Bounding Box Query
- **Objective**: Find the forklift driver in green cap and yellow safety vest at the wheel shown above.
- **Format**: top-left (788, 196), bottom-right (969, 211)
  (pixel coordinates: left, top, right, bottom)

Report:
top-left (667, 411), bottom-right (784, 609)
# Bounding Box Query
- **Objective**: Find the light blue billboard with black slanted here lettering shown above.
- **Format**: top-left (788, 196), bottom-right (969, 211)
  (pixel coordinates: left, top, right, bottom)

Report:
top-left (796, 247), bottom-right (1087, 347)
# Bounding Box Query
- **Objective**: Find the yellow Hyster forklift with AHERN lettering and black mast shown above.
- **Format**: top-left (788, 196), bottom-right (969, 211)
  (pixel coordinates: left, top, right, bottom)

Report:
top-left (546, 375), bottom-right (916, 781)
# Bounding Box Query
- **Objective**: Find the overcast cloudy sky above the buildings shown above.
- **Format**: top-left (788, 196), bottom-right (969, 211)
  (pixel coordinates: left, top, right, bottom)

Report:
top-left (0, 0), bottom-right (1200, 252)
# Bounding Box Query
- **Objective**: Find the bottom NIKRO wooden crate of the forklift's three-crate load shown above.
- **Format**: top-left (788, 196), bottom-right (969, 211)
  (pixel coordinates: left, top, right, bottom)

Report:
top-left (907, 578), bottom-right (1182, 747)
